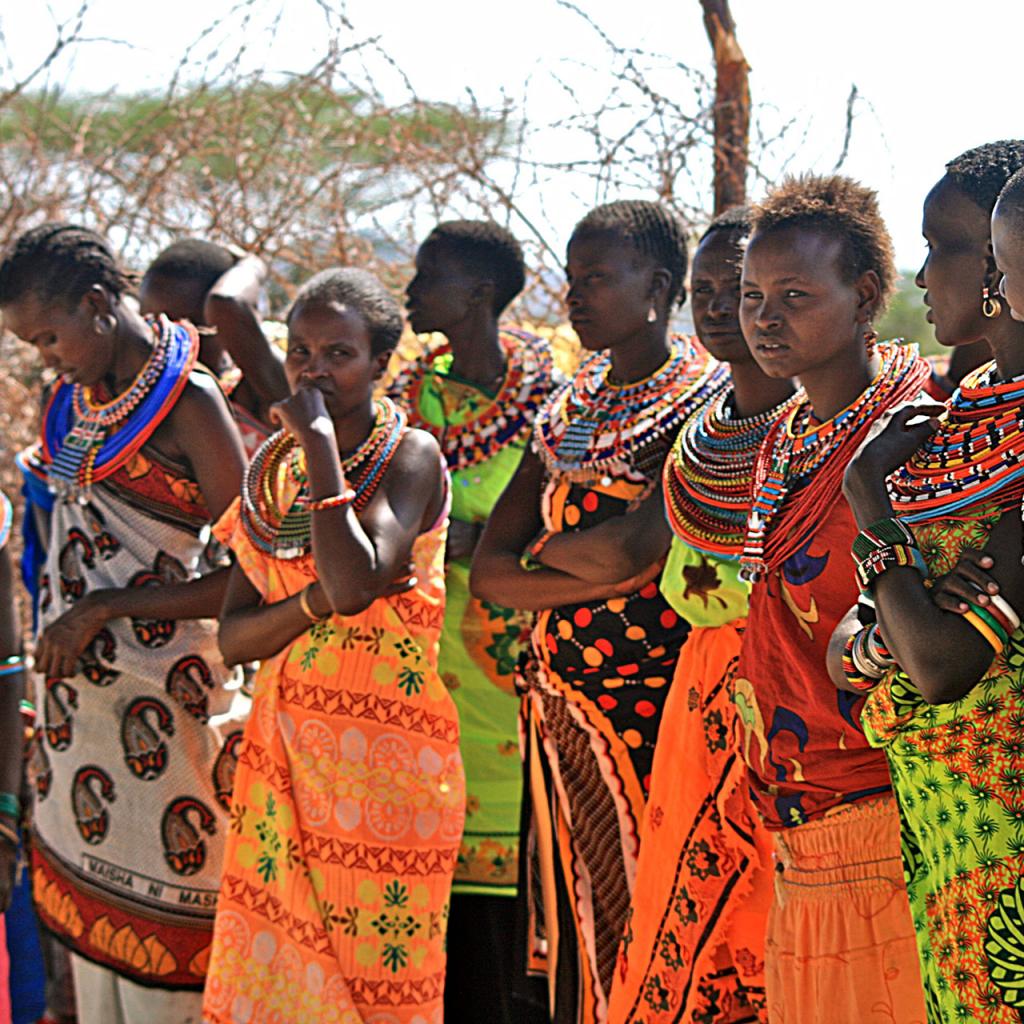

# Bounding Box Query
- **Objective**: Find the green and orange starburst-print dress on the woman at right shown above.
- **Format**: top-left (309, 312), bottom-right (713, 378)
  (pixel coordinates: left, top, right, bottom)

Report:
top-left (862, 513), bottom-right (1024, 1024)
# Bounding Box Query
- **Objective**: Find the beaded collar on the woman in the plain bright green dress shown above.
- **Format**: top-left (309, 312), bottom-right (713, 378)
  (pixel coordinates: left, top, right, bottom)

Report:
top-left (388, 330), bottom-right (553, 473)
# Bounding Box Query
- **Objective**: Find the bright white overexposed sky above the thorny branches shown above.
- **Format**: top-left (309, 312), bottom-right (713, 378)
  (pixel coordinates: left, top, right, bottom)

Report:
top-left (0, 0), bottom-right (1024, 269)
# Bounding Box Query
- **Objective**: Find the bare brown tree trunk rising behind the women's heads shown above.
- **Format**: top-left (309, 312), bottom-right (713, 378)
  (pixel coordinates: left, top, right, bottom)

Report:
top-left (700, 0), bottom-right (751, 214)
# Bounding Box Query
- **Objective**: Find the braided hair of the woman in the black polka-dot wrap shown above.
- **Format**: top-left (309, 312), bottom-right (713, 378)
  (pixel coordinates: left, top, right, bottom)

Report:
top-left (569, 200), bottom-right (689, 309)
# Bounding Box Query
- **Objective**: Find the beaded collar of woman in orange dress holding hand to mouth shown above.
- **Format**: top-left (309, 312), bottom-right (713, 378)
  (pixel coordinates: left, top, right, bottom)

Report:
top-left (242, 398), bottom-right (406, 559)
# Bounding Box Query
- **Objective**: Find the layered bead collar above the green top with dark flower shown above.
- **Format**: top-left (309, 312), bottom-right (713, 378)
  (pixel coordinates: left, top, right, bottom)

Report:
top-left (664, 387), bottom-right (804, 558)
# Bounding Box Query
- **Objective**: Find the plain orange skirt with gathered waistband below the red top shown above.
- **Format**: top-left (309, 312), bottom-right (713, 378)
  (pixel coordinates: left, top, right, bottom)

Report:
top-left (766, 797), bottom-right (927, 1024)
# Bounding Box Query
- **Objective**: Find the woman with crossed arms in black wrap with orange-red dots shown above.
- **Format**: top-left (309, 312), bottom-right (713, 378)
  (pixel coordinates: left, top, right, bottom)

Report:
top-left (471, 202), bottom-right (728, 1024)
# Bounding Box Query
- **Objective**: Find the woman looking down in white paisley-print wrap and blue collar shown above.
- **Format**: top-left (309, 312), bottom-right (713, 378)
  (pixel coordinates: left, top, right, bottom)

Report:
top-left (0, 224), bottom-right (248, 1024)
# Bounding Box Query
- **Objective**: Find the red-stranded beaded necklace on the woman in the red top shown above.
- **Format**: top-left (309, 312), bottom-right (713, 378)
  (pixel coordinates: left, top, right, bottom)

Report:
top-left (740, 342), bottom-right (930, 580)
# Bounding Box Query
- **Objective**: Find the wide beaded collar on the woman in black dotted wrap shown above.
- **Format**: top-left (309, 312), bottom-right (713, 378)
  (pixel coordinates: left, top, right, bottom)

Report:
top-left (534, 338), bottom-right (729, 486)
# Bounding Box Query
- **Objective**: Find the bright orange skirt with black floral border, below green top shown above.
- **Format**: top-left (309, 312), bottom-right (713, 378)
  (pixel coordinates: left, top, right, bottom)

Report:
top-left (608, 620), bottom-right (772, 1024)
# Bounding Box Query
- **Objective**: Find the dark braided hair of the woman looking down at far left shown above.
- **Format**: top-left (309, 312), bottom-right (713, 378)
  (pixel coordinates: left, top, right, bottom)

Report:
top-left (0, 222), bottom-right (134, 309)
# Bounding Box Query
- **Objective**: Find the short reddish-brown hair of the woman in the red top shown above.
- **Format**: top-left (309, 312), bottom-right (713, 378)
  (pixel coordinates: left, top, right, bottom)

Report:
top-left (753, 174), bottom-right (897, 313)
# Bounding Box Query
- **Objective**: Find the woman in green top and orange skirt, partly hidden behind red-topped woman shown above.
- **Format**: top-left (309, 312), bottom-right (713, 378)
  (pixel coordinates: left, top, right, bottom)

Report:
top-left (609, 208), bottom-right (799, 1024)
